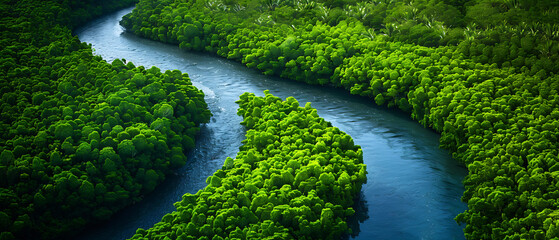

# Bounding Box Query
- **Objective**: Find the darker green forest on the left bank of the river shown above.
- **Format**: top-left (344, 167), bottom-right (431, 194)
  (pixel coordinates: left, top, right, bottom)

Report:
top-left (0, 1), bottom-right (211, 240)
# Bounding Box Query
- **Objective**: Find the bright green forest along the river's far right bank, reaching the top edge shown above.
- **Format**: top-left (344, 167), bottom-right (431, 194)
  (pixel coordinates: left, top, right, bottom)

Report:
top-left (122, 0), bottom-right (559, 239)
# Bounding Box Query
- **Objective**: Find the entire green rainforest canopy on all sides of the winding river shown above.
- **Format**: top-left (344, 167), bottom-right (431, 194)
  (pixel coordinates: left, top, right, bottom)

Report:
top-left (0, 0), bottom-right (559, 240)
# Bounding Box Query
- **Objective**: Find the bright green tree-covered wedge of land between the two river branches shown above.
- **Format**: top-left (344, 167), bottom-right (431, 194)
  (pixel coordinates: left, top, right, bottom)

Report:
top-left (133, 91), bottom-right (367, 239)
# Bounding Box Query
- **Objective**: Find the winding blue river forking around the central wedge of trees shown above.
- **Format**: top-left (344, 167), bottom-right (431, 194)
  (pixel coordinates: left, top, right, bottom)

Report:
top-left (75, 8), bottom-right (467, 240)
